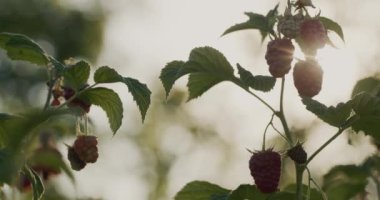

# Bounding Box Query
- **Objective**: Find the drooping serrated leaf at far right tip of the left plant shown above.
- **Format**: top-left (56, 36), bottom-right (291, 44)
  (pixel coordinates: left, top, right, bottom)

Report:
top-left (123, 77), bottom-right (152, 121)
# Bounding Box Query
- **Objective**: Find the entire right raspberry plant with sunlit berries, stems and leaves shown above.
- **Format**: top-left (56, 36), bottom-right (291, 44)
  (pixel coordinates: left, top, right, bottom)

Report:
top-left (160, 0), bottom-right (380, 200)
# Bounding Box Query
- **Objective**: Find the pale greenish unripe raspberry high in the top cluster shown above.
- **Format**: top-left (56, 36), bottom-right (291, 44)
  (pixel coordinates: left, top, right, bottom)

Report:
top-left (277, 15), bottom-right (303, 39)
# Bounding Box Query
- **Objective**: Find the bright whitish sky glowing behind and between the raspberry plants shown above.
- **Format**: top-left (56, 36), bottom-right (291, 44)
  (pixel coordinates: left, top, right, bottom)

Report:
top-left (51, 0), bottom-right (380, 200)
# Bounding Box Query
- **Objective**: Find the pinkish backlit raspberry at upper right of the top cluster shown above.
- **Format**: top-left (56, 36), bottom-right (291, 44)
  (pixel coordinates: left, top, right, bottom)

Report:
top-left (299, 18), bottom-right (328, 55)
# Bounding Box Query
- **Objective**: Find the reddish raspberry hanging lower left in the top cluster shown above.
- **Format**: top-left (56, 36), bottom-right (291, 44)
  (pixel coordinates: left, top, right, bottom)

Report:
top-left (265, 38), bottom-right (294, 78)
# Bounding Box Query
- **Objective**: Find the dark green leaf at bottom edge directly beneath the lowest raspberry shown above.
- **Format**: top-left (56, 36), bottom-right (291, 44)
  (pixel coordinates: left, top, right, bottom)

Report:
top-left (227, 184), bottom-right (268, 200)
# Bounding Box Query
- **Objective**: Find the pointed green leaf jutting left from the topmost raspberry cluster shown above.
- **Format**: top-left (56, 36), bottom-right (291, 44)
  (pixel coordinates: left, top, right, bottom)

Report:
top-left (222, 12), bottom-right (269, 36)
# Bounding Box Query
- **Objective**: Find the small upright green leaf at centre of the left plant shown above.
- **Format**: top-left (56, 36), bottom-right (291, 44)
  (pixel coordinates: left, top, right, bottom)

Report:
top-left (64, 61), bottom-right (91, 91)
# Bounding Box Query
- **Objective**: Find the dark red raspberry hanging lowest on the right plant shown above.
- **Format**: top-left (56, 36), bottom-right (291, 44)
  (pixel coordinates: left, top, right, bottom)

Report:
top-left (249, 149), bottom-right (281, 193)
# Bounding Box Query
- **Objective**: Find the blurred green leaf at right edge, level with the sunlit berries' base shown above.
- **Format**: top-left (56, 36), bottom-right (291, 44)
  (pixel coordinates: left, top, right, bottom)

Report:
top-left (351, 77), bottom-right (380, 98)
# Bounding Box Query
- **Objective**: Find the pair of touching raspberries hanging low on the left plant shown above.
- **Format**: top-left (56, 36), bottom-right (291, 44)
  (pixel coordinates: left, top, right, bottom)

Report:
top-left (67, 135), bottom-right (99, 171)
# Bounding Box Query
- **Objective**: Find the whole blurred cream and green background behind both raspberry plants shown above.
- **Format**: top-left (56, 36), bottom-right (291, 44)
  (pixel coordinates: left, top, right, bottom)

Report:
top-left (0, 0), bottom-right (380, 200)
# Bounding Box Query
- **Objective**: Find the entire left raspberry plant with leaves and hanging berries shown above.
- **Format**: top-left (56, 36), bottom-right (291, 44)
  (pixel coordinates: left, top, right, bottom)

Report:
top-left (0, 33), bottom-right (151, 200)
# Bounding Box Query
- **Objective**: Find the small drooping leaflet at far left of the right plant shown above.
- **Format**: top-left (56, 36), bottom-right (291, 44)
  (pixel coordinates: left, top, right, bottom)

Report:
top-left (160, 61), bottom-right (185, 97)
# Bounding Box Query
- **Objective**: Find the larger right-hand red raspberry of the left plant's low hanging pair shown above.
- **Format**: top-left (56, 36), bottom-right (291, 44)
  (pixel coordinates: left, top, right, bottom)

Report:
top-left (73, 135), bottom-right (99, 163)
